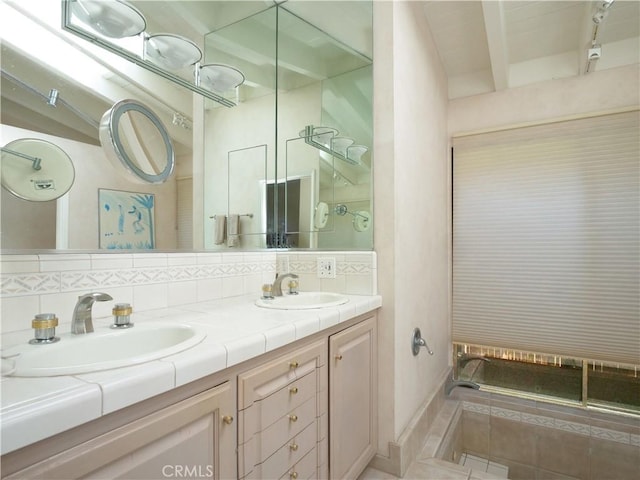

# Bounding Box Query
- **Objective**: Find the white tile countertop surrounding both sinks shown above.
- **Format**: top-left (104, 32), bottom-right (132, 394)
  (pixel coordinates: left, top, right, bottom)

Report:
top-left (0, 295), bottom-right (382, 454)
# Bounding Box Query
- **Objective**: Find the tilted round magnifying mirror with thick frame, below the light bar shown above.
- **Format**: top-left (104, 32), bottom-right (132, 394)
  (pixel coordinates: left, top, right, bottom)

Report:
top-left (100, 100), bottom-right (175, 183)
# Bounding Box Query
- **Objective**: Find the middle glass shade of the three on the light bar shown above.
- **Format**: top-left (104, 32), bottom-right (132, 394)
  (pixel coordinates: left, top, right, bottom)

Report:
top-left (144, 33), bottom-right (202, 70)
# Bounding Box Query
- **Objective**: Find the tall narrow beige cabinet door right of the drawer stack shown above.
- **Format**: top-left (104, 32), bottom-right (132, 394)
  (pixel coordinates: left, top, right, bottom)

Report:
top-left (329, 317), bottom-right (377, 479)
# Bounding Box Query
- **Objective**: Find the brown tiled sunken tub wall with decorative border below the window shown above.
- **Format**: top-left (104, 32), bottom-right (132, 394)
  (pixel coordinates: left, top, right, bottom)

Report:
top-left (442, 388), bottom-right (640, 480)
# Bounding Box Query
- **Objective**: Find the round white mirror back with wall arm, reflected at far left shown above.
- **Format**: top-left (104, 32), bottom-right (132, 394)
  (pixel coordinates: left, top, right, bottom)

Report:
top-left (0, 138), bottom-right (76, 202)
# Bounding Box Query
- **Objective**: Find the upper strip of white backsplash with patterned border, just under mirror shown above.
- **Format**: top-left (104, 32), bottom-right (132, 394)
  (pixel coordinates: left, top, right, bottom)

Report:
top-left (0, 252), bottom-right (376, 298)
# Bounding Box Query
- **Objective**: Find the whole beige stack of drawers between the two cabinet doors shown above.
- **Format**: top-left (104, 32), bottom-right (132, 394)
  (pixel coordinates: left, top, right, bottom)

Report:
top-left (238, 339), bottom-right (328, 479)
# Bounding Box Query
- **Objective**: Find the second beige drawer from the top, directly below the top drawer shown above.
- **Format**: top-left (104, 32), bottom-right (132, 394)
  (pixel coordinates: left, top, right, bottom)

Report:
top-left (238, 371), bottom-right (317, 443)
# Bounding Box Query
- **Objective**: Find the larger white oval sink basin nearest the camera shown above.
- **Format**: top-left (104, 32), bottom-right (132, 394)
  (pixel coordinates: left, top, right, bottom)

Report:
top-left (2, 323), bottom-right (206, 377)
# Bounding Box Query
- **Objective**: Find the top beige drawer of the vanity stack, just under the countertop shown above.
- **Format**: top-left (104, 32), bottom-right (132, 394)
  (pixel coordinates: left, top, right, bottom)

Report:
top-left (238, 340), bottom-right (327, 410)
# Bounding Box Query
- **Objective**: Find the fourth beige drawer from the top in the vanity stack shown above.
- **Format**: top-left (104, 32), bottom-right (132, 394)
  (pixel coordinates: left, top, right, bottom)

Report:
top-left (254, 422), bottom-right (318, 479)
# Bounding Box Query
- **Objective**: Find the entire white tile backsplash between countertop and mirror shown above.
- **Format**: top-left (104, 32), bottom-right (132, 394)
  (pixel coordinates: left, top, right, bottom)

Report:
top-left (0, 251), bottom-right (377, 333)
